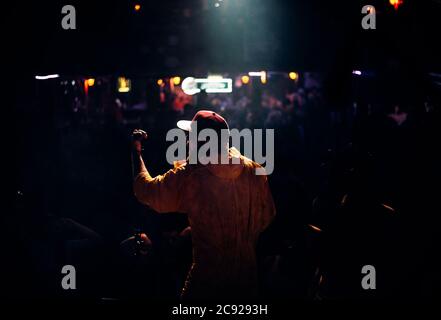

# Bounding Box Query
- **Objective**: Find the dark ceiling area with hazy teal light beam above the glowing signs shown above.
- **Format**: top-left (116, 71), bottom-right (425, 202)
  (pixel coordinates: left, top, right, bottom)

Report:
top-left (8, 0), bottom-right (441, 74)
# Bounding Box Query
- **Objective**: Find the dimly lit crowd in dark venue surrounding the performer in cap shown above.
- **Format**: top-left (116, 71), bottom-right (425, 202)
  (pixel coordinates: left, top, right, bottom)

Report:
top-left (10, 67), bottom-right (441, 300)
